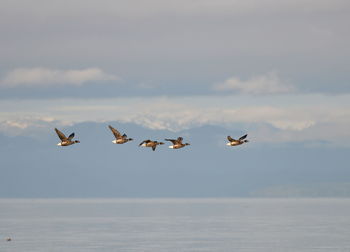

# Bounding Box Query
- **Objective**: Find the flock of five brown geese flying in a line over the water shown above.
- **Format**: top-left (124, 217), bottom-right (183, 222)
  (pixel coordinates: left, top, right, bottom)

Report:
top-left (55, 125), bottom-right (248, 151)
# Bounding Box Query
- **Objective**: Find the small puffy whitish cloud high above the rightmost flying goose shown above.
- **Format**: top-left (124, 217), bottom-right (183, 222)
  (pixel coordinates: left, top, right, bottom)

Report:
top-left (214, 72), bottom-right (295, 95)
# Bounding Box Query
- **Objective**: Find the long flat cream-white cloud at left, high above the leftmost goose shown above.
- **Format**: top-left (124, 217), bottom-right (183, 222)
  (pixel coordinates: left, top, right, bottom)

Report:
top-left (0, 67), bottom-right (118, 87)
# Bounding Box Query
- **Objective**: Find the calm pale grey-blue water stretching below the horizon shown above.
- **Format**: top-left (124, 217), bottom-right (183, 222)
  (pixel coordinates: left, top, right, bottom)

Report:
top-left (0, 199), bottom-right (350, 252)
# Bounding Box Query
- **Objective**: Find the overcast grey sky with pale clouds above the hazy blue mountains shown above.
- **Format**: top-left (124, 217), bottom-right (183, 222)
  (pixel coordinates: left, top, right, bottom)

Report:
top-left (0, 0), bottom-right (350, 146)
